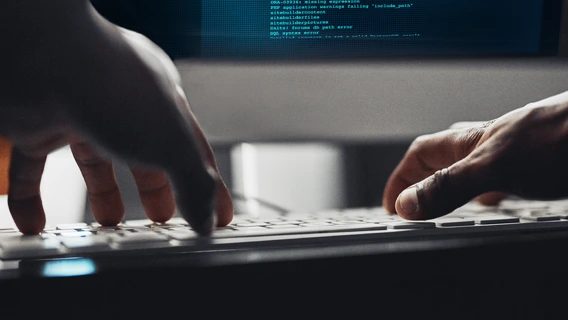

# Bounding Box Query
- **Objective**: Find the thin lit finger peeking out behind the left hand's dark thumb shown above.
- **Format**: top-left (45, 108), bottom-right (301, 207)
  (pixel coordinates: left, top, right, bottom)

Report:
top-left (177, 86), bottom-right (234, 227)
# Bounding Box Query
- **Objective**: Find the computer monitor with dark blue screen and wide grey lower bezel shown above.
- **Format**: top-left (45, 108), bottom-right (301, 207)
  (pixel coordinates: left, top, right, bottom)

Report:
top-left (93, 0), bottom-right (568, 145)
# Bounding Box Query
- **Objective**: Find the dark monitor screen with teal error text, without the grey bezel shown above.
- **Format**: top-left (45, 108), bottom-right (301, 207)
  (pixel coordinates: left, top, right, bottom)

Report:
top-left (92, 0), bottom-right (562, 60)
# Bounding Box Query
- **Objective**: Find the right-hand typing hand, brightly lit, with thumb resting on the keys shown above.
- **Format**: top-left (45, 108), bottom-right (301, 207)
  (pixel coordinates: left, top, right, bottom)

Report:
top-left (383, 92), bottom-right (568, 220)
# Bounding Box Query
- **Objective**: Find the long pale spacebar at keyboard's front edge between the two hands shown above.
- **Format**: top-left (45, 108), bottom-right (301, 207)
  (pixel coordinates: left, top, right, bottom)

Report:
top-left (212, 223), bottom-right (387, 238)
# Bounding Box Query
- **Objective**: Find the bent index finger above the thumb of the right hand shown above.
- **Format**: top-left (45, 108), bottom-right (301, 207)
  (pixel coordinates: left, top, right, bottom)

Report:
top-left (383, 128), bottom-right (483, 214)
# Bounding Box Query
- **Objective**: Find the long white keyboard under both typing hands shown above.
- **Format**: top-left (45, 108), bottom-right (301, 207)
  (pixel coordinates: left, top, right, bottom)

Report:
top-left (0, 200), bottom-right (568, 262)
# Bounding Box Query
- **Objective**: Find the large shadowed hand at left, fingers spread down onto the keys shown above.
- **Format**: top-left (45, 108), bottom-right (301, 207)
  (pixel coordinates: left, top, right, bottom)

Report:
top-left (0, 0), bottom-right (233, 234)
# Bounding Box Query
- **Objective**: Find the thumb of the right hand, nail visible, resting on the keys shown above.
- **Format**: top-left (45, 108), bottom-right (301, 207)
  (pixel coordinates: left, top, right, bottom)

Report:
top-left (395, 157), bottom-right (491, 220)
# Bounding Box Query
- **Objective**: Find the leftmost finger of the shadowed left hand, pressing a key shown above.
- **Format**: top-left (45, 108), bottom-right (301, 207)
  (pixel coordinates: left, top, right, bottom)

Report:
top-left (8, 148), bottom-right (47, 234)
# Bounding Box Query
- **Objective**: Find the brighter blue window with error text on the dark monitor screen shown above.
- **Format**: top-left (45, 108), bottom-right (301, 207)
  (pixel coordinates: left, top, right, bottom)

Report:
top-left (201, 0), bottom-right (560, 59)
